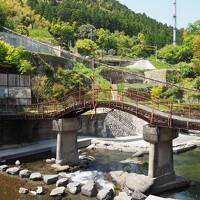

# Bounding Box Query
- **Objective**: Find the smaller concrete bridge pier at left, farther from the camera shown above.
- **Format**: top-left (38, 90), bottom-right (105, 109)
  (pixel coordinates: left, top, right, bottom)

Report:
top-left (53, 118), bottom-right (80, 165)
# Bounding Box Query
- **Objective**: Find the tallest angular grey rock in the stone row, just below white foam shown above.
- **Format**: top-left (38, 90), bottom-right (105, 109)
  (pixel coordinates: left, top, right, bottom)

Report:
top-left (81, 180), bottom-right (97, 197)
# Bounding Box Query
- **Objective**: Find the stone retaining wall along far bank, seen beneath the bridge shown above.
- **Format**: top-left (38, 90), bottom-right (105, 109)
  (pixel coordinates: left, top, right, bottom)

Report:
top-left (0, 111), bottom-right (146, 146)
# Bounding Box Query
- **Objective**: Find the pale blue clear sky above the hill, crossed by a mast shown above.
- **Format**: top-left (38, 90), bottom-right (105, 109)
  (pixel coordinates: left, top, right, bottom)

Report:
top-left (118, 0), bottom-right (200, 28)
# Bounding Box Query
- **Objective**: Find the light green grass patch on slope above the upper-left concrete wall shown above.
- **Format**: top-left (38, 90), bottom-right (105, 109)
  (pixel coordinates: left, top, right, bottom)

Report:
top-left (29, 29), bottom-right (53, 41)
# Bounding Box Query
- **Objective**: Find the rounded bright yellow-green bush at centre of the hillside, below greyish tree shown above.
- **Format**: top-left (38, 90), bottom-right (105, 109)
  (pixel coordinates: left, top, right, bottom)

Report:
top-left (76, 39), bottom-right (98, 56)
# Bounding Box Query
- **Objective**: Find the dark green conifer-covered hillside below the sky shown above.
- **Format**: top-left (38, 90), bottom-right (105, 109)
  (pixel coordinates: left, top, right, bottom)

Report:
top-left (27, 0), bottom-right (182, 47)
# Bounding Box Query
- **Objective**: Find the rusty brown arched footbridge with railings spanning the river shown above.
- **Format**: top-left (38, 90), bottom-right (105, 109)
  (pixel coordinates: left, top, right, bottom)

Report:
top-left (0, 90), bottom-right (200, 130)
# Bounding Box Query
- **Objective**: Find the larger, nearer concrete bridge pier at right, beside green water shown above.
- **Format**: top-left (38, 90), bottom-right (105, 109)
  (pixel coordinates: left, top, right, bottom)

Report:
top-left (143, 125), bottom-right (178, 186)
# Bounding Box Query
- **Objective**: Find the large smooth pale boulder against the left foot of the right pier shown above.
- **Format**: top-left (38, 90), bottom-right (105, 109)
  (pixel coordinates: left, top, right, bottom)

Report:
top-left (125, 173), bottom-right (153, 193)
